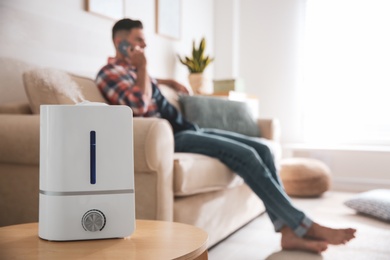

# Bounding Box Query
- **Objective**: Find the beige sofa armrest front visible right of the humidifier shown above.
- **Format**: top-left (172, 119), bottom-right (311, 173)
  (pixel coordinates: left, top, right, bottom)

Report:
top-left (134, 118), bottom-right (174, 221)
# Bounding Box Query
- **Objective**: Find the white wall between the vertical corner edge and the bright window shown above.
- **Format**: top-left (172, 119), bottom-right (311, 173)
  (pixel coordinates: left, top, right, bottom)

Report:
top-left (240, 0), bottom-right (306, 143)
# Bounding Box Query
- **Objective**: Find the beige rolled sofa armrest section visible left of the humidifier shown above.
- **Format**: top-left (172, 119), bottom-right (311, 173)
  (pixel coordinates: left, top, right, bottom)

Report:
top-left (0, 114), bottom-right (39, 165)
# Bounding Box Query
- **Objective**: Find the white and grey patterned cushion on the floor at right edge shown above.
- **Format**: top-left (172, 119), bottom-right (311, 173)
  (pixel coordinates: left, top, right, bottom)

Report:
top-left (344, 189), bottom-right (390, 221)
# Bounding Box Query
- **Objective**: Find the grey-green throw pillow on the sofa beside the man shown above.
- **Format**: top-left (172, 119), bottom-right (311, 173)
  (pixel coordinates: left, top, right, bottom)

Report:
top-left (179, 96), bottom-right (260, 137)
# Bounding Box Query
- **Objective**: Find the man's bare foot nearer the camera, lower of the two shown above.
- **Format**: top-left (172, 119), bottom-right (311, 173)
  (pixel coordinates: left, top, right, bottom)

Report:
top-left (280, 226), bottom-right (328, 254)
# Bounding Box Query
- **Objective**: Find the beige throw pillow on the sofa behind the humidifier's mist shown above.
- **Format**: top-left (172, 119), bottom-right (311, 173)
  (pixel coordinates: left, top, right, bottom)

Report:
top-left (23, 68), bottom-right (84, 114)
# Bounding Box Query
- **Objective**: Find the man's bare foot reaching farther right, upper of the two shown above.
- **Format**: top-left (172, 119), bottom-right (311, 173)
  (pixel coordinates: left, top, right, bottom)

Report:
top-left (305, 223), bottom-right (356, 245)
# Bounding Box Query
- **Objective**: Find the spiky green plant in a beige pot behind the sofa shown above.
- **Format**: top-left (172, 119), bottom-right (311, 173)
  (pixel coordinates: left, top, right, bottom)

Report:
top-left (178, 37), bottom-right (214, 94)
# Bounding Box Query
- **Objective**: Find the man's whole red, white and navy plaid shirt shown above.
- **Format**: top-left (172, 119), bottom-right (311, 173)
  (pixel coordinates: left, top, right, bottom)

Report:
top-left (96, 58), bottom-right (161, 117)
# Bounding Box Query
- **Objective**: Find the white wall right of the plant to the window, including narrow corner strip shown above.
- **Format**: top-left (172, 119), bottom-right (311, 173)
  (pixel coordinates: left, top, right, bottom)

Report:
top-left (215, 0), bottom-right (306, 143)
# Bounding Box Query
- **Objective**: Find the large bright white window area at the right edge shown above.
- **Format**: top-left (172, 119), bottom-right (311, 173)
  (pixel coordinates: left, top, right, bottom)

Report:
top-left (304, 0), bottom-right (390, 145)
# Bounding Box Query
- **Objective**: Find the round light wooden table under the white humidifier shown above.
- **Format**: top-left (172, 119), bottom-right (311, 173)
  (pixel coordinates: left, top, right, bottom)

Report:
top-left (0, 220), bottom-right (208, 260)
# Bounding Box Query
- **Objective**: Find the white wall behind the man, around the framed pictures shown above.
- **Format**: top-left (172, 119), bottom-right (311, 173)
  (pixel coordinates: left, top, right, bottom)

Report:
top-left (0, 0), bottom-right (214, 86)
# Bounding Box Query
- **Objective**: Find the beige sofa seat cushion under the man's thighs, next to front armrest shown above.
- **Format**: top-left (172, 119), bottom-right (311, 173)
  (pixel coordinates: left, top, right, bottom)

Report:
top-left (174, 153), bottom-right (243, 196)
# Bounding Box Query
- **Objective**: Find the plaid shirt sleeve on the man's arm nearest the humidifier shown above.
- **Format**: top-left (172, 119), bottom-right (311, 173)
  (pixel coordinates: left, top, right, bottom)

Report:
top-left (96, 64), bottom-right (149, 116)
